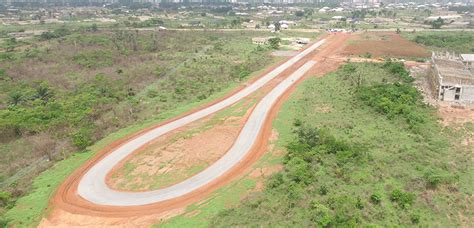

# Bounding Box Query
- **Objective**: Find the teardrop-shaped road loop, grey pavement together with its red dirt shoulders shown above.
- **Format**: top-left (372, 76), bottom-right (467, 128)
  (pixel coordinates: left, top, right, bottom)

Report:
top-left (43, 34), bottom-right (350, 226)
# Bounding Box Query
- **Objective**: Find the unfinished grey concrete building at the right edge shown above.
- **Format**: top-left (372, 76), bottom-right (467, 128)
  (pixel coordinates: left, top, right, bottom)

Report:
top-left (430, 52), bottom-right (474, 103)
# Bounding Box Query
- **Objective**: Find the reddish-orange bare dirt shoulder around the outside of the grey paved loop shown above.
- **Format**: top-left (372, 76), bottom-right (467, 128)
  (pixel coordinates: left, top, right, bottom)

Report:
top-left (41, 33), bottom-right (351, 226)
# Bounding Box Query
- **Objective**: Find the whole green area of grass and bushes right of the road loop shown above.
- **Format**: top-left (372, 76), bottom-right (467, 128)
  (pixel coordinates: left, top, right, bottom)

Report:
top-left (211, 63), bottom-right (474, 227)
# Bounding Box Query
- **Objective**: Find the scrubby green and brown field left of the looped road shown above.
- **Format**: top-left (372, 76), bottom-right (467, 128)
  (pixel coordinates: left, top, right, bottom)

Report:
top-left (0, 28), bottom-right (278, 219)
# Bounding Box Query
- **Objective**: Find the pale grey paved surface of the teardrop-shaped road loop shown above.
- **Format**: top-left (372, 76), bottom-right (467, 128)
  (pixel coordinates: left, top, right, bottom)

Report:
top-left (78, 40), bottom-right (325, 206)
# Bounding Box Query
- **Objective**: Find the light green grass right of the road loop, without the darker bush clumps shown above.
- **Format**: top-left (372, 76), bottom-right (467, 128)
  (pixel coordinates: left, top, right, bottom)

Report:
top-left (211, 64), bottom-right (474, 227)
